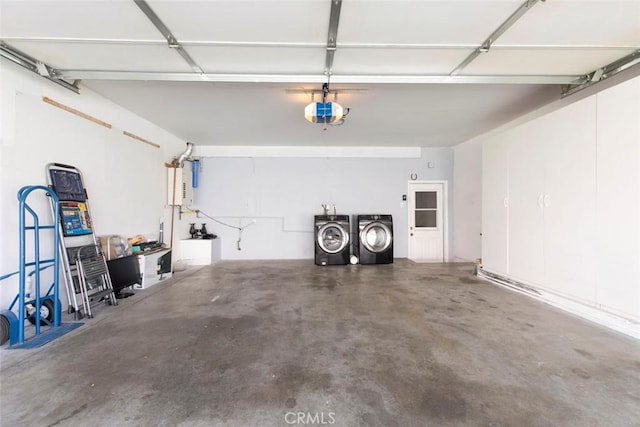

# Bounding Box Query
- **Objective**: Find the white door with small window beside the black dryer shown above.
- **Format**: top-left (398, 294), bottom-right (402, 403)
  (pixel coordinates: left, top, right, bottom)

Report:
top-left (409, 182), bottom-right (446, 262)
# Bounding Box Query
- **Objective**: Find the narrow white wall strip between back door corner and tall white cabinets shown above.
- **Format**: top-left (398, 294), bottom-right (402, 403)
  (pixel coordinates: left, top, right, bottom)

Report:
top-left (453, 141), bottom-right (482, 261)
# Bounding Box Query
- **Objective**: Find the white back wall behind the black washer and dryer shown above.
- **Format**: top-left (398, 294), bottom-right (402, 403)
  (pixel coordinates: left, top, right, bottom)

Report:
top-left (190, 148), bottom-right (453, 259)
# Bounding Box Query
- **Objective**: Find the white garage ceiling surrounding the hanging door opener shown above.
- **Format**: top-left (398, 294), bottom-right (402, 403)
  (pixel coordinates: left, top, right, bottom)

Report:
top-left (0, 0), bottom-right (640, 146)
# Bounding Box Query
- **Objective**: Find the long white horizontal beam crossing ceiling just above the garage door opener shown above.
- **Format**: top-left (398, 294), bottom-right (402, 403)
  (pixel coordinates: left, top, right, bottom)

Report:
top-left (59, 70), bottom-right (584, 85)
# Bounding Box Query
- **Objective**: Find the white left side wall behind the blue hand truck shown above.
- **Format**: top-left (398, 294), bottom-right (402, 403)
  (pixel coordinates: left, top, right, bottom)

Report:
top-left (0, 61), bottom-right (187, 308)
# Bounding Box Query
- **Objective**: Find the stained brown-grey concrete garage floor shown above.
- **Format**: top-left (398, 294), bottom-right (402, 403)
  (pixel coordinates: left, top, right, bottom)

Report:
top-left (0, 260), bottom-right (640, 426)
